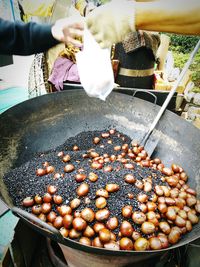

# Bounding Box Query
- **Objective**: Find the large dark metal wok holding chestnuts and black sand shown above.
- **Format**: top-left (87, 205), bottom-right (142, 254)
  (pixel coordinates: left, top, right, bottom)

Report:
top-left (0, 89), bottom-right (200, 258)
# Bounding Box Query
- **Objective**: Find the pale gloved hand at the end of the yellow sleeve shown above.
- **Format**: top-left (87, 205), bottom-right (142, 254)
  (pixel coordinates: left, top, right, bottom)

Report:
top-left (86, 0), bottom-right (135, 48)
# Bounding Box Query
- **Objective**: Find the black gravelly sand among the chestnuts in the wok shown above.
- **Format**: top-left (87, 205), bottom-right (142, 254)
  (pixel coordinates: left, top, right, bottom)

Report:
top-left (4, 130), bottom-right (165, 237)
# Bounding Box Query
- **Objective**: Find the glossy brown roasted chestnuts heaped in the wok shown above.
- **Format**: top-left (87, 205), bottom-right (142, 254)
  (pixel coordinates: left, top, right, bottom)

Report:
top-left (23, 129), bottom-right (200, 251)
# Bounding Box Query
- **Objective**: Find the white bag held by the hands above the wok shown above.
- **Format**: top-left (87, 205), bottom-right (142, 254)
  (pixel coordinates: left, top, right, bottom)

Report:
top-left (76, 29), bottom-right (114, 100)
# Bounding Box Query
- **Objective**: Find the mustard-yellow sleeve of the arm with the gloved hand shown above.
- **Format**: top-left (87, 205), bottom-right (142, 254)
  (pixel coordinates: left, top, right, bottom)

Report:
top-left (135, 0), bottom-right (200, 35)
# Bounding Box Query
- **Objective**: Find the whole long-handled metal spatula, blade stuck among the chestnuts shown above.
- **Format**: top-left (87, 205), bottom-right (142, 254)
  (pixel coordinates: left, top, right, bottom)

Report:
top-left (132, 40), bottom-right (200, 157)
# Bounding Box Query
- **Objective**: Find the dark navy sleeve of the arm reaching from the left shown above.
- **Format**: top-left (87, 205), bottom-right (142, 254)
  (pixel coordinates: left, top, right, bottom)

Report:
top-left (0, 18), bottom-right (59, 55)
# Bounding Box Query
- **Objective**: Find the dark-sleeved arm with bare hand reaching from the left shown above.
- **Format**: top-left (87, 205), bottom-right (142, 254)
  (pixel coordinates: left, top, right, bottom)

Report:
top-left (0, 18), bottom-right (83, 55)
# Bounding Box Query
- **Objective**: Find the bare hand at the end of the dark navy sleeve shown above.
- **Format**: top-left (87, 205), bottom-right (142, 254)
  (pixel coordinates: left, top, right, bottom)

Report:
top-left (51, 16), bottom-right (84, 46)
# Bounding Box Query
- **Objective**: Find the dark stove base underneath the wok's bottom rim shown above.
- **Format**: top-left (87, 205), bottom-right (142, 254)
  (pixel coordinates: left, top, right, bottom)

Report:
top-left (2, 220), bottom-right (200, 267)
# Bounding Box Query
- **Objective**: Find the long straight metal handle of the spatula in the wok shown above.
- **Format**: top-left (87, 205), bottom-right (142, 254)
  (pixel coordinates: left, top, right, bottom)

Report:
top-left (141, 40), bottom-right (200, 146)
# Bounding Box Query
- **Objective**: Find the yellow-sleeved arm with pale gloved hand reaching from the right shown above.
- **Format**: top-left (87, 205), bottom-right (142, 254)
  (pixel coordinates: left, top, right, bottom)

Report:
top-left (86, 0), bottom-right (200, 48)
